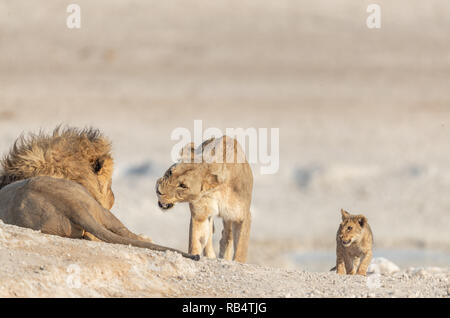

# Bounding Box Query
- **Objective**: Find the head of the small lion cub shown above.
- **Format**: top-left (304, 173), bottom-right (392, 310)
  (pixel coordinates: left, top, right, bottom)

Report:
top-left (338, 209), bottom-right (367, 247)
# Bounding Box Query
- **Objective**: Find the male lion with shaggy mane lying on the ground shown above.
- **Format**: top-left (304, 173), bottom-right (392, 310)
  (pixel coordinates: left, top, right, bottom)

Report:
top-left (0, 127), bottom-right (199, 259)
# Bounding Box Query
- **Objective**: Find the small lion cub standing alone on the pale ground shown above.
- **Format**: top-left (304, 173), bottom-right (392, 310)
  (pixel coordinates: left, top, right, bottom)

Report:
top-left (335, 209), bottom-right (373, 275)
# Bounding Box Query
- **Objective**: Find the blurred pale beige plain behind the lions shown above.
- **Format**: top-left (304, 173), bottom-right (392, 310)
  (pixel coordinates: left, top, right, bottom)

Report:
top-left (0, 0), bottom-right (450, 271)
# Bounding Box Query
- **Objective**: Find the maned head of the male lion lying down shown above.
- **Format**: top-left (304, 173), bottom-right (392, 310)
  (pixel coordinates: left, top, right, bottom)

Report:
top-left (0, 127), bottom-right (114, 210)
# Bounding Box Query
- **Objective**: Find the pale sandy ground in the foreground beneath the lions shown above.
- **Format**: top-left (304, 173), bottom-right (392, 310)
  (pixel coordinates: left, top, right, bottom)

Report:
top-left (0, 223), bottom-right (450, 298)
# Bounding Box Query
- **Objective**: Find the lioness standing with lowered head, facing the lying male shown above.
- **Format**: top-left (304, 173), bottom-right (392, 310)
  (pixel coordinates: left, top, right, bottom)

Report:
top-left (156, 136), bottom-right (253, 262)
